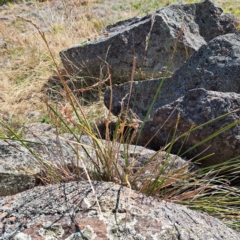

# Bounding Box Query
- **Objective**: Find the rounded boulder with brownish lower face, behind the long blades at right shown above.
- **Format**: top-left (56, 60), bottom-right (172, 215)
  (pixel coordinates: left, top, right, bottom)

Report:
top-left (138, 88), bottom-right (240, 167)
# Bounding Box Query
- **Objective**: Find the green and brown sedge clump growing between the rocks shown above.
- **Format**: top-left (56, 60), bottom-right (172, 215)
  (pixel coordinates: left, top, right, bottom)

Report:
top-left (1, 0), bottom-right (240, 232)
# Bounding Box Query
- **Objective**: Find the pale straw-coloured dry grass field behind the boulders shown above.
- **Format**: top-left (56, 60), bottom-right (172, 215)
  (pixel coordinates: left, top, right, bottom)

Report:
top-left (0, 0), bottom-right (240, 135)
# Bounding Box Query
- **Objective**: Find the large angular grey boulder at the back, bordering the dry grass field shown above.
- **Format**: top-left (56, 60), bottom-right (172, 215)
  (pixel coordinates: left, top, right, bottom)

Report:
top-left (60, 0), bottom-right (237, 85)
